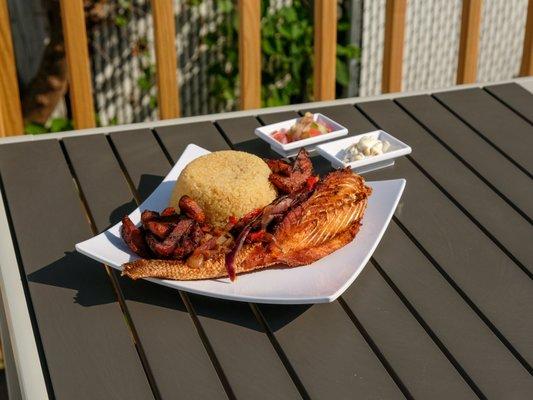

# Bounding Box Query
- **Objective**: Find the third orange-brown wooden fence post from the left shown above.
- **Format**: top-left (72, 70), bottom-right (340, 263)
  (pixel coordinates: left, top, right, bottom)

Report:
top-left (150, 0), bottom-right (180, 119)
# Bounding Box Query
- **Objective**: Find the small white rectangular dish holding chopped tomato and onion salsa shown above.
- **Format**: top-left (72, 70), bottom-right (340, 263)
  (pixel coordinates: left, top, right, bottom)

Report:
top-left (255, 113), bottom-right (348, 157)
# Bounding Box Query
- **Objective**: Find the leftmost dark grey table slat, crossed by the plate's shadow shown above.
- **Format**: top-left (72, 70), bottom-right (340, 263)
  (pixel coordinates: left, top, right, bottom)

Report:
top-left (0, 140), bottom-right (152, 399)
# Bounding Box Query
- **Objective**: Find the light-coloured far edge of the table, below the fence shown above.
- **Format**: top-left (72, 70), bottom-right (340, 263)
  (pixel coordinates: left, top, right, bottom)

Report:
top-left (0, 76), bottom-right (533, 145)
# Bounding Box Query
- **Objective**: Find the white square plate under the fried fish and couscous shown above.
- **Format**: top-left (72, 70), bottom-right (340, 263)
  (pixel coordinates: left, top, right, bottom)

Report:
top-left (76, 144), bottom-right (405, 304)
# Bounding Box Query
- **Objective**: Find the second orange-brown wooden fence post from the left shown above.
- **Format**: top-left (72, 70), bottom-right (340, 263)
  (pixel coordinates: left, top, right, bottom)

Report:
top-left (60, 0), bottom-right (96, 129)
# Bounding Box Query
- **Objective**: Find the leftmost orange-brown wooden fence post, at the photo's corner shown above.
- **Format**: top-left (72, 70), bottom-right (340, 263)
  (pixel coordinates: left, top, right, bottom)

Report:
top-left (0, 0), bottom-right (24, 137)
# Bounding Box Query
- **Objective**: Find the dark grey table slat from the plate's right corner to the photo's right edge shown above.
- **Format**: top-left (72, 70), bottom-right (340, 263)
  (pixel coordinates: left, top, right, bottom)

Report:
top-left (324, 103), bottom-right (533, 365)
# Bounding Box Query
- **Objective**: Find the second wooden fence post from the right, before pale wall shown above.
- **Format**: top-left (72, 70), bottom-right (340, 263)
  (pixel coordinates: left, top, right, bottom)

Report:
top-left (457, 0), bottom-right (483, 84)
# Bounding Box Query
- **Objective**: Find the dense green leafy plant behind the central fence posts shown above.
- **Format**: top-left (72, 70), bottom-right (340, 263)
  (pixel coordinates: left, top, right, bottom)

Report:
top-left (202, 0), bottom-right (360, 110)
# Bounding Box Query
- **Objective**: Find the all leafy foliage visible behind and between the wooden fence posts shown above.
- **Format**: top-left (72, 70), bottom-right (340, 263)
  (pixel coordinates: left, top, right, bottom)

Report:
top-left (25, 0), bottom-right (359, 134)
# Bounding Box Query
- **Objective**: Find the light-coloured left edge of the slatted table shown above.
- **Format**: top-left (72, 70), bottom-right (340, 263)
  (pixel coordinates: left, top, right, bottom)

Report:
top-left (0, 184), bottom-right (49, 399)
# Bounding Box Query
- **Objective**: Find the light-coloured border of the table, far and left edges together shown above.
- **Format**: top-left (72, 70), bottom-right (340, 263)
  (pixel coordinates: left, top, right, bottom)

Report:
top-left (0, 77), bottom-right (533, 399)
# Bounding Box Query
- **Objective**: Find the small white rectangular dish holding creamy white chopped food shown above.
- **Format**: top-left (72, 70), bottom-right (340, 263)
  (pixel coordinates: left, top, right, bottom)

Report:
top-left (317, 130), bottom-right (412, 174)
